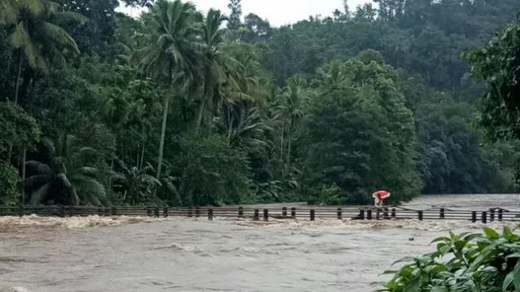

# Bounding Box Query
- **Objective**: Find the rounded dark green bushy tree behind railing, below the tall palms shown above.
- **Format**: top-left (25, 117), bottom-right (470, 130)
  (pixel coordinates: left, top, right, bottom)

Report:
top-left (174, 133), bottom-right (251, 206)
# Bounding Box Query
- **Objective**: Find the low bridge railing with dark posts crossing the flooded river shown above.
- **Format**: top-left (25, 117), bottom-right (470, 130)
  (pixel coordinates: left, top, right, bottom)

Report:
top-left (0, 206), bottom-right (520, 223)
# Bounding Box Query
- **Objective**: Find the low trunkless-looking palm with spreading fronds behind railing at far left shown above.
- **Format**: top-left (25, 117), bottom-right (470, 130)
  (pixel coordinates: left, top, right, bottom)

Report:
top-left (25, 135), bottom-right (108, 206)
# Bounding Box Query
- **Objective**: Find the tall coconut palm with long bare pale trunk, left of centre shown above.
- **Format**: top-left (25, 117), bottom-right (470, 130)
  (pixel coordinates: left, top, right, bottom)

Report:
top-left (137, 0), bottom-right (202, 178)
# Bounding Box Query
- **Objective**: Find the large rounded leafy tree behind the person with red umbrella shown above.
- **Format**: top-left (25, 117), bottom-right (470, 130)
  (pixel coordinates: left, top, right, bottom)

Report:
top-left (303, 55), bottom-right (421, 203)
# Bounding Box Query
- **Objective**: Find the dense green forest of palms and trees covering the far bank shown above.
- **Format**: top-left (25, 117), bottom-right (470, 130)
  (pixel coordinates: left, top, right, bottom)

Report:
top-left (0, 0), bottom-right (520, 206)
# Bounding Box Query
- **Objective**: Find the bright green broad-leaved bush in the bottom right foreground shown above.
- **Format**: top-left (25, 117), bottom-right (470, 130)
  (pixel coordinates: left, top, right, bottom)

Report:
top-left (381, 227), bottom-right (520, 292)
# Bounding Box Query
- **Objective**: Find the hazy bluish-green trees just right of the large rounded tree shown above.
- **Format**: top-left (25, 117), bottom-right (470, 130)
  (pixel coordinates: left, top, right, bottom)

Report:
top-left (416, 94), bottom-right (504, 194)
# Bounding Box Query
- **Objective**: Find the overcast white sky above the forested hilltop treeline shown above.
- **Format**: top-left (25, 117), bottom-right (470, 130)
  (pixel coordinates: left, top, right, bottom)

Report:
top-left (119, 0), bottom-right (372, 26)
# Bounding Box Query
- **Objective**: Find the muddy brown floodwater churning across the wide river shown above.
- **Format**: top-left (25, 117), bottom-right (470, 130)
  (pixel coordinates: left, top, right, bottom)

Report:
top-left (0, 195), bottom-right (520, 292)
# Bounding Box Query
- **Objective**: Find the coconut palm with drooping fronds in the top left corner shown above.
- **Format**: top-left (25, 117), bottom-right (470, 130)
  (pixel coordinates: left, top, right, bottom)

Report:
top-left (6, 0), bottom-right (87, 103)
